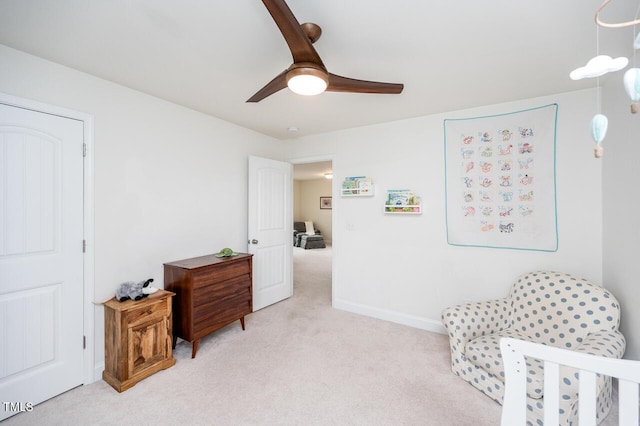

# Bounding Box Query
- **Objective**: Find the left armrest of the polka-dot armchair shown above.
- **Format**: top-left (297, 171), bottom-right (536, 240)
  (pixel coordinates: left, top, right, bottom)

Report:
top-left (442, 298), bottom-right (511, 375)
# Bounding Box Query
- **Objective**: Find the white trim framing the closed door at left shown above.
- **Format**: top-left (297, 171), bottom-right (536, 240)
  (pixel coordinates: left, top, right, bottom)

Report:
top-left (0, 92), bottom-right (95, 385)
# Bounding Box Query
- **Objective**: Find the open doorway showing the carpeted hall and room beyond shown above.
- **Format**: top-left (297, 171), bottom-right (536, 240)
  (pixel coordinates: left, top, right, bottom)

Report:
top-left (292, 160), bottom-right (333, 306)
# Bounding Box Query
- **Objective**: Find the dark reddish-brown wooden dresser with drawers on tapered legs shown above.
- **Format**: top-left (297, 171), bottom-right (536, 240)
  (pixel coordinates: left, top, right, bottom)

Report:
top-left (164, 253), bottom-right (253, 358)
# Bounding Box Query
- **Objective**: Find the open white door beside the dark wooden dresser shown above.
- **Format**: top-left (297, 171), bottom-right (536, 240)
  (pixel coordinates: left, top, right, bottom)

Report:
top-left (248, 156), bottom-right (293, 311)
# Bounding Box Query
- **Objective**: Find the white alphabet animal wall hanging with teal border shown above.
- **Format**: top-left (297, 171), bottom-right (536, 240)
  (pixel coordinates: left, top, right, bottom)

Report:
top-left (444, 104), bottom-right (558, 251)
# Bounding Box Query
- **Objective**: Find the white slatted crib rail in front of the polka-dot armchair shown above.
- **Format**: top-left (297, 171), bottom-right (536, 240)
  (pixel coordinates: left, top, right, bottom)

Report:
top-left (500, 338), bottom-right (640, 426)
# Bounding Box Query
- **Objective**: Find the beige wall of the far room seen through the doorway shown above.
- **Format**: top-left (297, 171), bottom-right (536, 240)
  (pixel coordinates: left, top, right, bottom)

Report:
top-left (293, 179), bottom-right (333, 244)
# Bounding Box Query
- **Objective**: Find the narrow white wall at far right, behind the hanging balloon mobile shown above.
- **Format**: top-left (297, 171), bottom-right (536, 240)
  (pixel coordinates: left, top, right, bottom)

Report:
top-left (602, 72), bottom-right (640, 359)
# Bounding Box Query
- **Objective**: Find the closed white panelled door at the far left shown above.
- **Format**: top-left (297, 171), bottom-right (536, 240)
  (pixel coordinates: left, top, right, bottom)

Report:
top-left (0, 104), bottom-right (84, 420)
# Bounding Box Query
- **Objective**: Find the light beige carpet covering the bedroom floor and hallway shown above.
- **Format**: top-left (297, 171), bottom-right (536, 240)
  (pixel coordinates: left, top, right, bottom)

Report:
top-left (3, 247), bottom-right (616, 426)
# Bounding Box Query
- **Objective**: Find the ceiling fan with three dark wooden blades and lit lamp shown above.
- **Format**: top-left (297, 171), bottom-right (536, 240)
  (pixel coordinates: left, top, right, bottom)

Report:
top-left (247, 0), bottom-right (404, 102)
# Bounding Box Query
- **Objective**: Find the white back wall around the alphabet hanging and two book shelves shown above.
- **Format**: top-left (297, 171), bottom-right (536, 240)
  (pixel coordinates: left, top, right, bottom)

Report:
top-left (287, 90), bottom-right (602, 332)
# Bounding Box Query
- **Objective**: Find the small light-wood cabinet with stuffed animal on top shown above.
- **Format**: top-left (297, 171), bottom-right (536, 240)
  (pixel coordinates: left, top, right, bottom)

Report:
top-left (102, 290), bottom-right (176, 392)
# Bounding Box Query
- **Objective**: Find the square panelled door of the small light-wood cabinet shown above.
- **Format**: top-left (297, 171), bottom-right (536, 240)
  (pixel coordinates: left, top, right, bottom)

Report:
top-left (128, 317), bottom-right (171, 378)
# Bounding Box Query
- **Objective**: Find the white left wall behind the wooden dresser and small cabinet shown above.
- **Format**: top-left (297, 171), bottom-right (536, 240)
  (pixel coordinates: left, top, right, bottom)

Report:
top-left (0, 45), bottom-right (283, 378)
